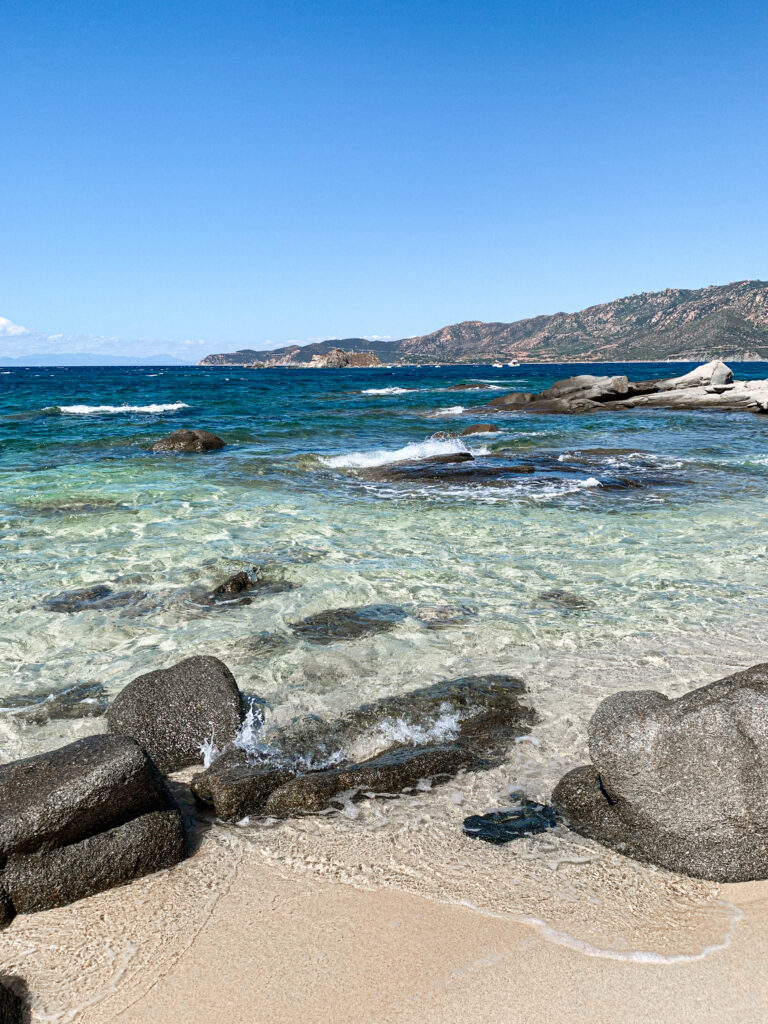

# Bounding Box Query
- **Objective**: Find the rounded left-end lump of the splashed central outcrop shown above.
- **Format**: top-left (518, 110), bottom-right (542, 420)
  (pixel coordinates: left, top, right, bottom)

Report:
top-left (191, 746), bottom-right (296, 821)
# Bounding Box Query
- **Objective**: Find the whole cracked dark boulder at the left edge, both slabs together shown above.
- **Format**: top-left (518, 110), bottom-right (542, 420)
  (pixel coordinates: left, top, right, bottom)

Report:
top-left (0, 735), bottom-right (186, 923)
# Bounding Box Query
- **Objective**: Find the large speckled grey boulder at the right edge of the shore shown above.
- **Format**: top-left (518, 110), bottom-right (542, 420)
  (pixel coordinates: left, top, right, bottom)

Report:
top-left (553, 665), bottom-right (768, 882)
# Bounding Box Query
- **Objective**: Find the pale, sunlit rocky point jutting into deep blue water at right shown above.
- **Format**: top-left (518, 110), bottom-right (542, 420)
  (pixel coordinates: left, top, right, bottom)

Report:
top-left (487, 359), bottom-right (768, 413)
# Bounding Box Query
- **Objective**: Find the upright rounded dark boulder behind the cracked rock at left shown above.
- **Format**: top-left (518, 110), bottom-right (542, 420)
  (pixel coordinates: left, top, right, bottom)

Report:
top-left (108, 655), bottom-right (243, 771)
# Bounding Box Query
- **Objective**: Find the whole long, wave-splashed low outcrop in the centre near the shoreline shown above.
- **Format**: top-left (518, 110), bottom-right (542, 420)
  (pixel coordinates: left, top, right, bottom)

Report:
top-left (193, 676), bottom-right (535, 820)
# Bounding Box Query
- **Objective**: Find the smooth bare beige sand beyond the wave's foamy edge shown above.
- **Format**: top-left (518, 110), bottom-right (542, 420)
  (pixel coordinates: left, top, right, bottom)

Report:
top-left (87, 860), bottom-right (768, 1024)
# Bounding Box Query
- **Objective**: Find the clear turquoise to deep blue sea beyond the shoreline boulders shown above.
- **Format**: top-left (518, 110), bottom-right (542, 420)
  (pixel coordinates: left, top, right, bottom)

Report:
top-left (0, 364), bottom-right (768, 774)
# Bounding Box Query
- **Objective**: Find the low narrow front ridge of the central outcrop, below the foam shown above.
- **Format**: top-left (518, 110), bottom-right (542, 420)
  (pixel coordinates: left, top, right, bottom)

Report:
top-left (264, 743), bottom-right (476, 817)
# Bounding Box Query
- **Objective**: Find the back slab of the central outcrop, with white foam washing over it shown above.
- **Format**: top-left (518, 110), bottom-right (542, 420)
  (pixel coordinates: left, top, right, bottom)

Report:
top-left (269, 675), bottom-right (536, 761)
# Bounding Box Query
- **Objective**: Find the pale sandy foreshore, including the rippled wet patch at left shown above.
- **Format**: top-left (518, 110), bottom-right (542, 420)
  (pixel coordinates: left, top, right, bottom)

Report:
top-left (0, 828), bottom-right (768, 1024)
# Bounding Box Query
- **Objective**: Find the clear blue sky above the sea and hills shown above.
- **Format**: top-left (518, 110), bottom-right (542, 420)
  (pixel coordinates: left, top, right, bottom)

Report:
top-left (0, 0), bottom-right (768, 357)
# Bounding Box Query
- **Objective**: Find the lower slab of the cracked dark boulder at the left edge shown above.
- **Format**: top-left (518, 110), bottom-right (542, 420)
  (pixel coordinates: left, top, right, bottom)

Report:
top-left (2, 809), bottom-right (186, 913)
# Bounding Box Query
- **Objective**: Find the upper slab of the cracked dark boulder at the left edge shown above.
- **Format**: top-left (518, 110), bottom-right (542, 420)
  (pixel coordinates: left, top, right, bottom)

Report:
top-left (0, 735), bottom-right (171, 860)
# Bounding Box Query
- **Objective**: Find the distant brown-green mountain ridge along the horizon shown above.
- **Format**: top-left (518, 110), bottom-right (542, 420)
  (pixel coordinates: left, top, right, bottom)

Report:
top-left (201, 281), bottom-right (768, 366)
